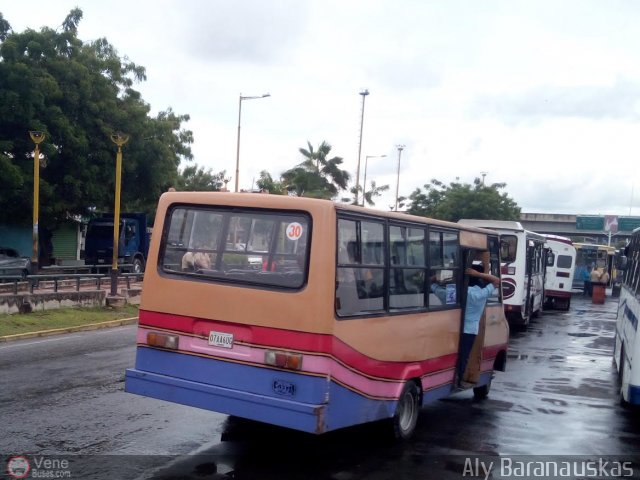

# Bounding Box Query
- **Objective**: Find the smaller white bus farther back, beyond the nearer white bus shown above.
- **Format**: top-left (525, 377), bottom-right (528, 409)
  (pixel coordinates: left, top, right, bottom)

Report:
top-left (544, 235), bottom-right (576, 310)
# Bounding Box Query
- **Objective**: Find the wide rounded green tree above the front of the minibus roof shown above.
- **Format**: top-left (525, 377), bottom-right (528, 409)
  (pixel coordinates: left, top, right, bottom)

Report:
top-left (407, 178), bottom-right (520, 222)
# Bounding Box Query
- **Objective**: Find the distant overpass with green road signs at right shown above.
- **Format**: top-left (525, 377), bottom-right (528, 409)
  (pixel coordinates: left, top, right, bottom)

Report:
top-left (520, 213), bottom-right (640, 247)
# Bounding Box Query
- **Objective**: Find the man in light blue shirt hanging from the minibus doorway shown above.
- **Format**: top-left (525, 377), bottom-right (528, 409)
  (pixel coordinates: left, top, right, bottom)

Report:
top-left (456, 252), bottom-right (500, 388)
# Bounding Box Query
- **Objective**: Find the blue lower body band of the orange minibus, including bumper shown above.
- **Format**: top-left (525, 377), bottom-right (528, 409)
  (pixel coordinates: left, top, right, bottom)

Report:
top-left (125, 348), bottom-right (408, 433)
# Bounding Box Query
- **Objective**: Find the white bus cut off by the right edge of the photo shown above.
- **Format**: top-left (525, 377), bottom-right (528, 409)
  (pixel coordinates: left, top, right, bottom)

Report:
top-left (613, 228), bottom-right (640, 405)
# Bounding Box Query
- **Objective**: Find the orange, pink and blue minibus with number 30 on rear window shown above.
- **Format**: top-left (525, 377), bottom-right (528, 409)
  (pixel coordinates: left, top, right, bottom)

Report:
top-left (125, 192), bottom-right (509, 438)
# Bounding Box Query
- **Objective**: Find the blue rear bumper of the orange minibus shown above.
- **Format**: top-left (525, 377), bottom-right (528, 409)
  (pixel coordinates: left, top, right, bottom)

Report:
top-left (125, 368), bottom-right (327, 434)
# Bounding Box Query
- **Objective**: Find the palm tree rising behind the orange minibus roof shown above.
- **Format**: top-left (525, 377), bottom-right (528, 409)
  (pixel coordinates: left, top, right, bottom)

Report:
top-left (282, 141), bottom-right (350, 199)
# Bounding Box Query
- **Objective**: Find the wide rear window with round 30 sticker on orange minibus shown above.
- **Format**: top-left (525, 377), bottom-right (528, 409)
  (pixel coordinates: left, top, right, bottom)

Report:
top-left (159, 207), bottom-right (311, 288)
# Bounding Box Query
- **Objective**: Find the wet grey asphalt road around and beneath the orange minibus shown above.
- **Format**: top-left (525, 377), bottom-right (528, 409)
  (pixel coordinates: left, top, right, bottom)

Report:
top-left (0, 297), bottom-right (640, 480)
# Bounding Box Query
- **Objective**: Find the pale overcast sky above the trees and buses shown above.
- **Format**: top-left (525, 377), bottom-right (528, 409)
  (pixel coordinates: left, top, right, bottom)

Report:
top-left (0, 0), bottom-right (640, 215)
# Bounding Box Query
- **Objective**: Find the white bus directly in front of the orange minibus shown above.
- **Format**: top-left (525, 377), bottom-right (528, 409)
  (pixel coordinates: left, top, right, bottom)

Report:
top-left (458, 219), bottom-right (545, 326)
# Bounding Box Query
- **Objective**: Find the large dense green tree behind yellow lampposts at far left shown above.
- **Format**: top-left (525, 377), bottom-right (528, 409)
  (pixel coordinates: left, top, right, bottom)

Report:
top-left (0, 8), bottom-right (193, 226)
